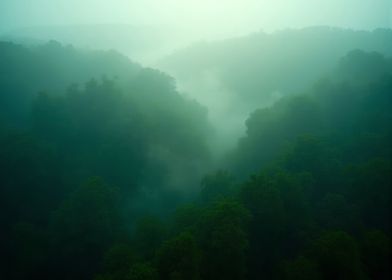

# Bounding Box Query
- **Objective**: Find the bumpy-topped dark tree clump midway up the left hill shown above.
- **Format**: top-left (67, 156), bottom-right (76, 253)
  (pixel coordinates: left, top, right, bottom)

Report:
top-left (33, 76), bottom-right (146, 188)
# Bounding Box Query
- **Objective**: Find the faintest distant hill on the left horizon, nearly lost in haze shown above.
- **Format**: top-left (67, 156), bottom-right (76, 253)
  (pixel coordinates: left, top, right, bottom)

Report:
top-left (0, 23), bottom-right (187, 62)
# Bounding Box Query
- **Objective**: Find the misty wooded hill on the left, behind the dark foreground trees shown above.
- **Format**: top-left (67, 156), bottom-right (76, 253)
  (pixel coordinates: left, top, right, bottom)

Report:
top-left (0, 42), bottom-right (210, 240)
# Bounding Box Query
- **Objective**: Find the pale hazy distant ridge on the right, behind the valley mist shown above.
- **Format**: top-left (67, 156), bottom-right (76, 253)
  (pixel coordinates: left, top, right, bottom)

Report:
top-left (159, 27), bottom-right (392, 108)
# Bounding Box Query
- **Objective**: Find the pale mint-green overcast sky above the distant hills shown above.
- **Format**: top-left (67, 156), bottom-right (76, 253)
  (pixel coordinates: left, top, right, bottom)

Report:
top-left (0, 0), bottom-right (392, 36)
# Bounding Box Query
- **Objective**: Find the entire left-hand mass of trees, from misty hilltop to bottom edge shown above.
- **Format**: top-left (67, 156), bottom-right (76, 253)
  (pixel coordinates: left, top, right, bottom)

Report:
top-left (0, 42), bottom-right (210, 279)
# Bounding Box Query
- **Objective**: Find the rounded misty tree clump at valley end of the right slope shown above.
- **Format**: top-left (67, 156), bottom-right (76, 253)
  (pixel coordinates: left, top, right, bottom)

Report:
top-left (235, 96), bottom-right (323, 174)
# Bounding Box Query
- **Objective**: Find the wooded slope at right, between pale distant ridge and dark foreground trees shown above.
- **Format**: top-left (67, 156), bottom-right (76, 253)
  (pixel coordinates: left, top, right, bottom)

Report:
top-left (229, 50), bottom-right (392, 177)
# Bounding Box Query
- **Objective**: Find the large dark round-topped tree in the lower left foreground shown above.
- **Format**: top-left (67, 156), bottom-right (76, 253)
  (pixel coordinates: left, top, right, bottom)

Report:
top-left (50, 178), bottom-right (122, 278)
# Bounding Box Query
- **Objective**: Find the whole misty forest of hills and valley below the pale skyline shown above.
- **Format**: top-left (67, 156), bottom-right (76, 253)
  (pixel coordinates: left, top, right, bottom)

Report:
top-left (0, 8), bottom-right (392, 280)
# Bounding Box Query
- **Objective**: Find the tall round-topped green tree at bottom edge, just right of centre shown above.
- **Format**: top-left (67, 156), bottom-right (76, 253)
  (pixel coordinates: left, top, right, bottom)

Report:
top-left (198, 200), bottom-right (250, 279)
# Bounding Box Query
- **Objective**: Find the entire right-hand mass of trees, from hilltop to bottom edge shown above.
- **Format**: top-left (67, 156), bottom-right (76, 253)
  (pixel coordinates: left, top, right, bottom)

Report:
top-left (109, 51), bottom-right (392, 279)
